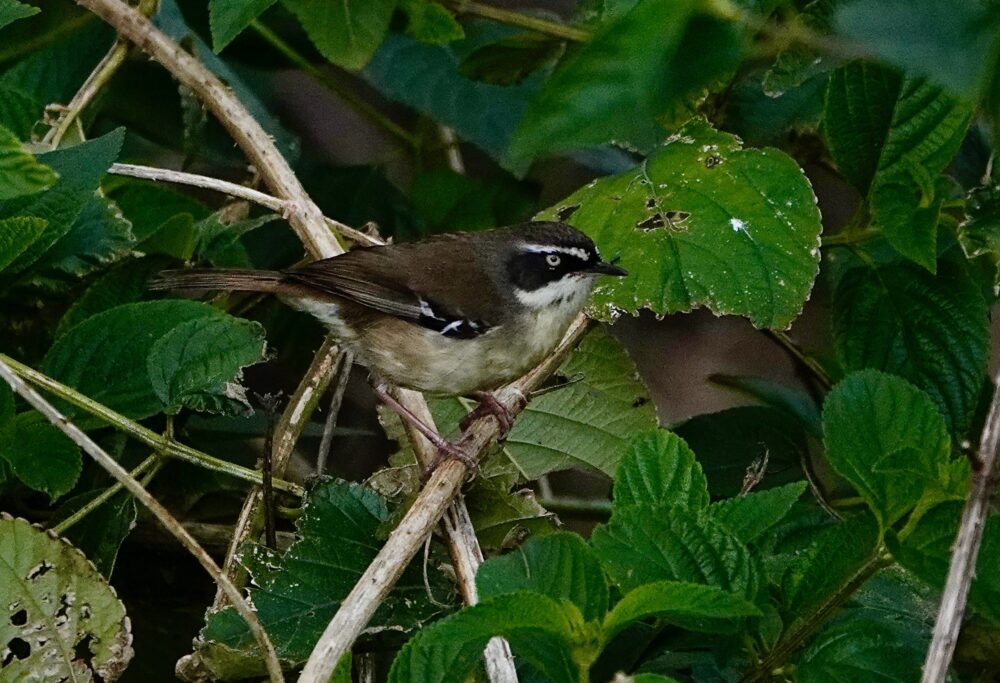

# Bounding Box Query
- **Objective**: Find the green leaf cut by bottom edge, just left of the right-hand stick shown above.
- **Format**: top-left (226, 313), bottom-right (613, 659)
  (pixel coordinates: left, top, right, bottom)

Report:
top-left (795, 619), bottom-right (924, 683)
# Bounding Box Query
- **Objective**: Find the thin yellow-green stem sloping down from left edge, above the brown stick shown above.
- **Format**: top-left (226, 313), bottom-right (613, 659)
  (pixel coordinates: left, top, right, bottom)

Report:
top-left (0, 353), bottom-right (305, 498)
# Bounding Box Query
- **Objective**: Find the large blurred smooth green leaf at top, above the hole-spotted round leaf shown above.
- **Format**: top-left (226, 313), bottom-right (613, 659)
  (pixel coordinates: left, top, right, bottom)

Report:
top-left (511, 0), bottom-right (743, 158)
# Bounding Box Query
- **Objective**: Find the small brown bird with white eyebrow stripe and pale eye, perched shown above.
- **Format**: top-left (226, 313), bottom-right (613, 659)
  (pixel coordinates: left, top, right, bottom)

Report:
top-left (150, 221), bottom-right (628, 468)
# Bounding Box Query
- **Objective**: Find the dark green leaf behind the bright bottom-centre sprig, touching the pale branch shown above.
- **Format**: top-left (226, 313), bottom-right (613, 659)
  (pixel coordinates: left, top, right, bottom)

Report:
top-left (476, 532), bottom-right (608, 621)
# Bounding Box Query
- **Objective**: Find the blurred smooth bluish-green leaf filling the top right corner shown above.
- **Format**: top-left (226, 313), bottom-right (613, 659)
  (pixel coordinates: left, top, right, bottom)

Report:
top-left (835, 0), bottom-right (997, 98)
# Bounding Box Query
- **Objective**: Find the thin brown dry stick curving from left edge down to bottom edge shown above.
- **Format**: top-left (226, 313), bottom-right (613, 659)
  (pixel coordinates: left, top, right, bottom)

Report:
top-left (0, 361), bottom-right (284, 683)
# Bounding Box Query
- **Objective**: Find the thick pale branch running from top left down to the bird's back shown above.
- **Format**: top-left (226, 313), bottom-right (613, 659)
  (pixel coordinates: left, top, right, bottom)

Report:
top-left (77, 0), bottom-right (344, 258)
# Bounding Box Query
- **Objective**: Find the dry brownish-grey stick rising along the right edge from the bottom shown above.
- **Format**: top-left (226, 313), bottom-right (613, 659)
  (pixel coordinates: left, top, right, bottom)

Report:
top-left (921, 376), bottom-right (1000, 683)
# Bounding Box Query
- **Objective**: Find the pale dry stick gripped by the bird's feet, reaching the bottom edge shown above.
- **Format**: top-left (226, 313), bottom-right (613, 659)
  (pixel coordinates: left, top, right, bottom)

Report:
top-left (299, 315), bottom-right (587, 683)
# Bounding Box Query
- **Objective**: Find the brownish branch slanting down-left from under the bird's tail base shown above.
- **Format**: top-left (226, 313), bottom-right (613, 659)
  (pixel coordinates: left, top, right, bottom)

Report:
top-left (212, 337), bottom-right (340, 609)
